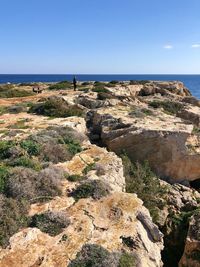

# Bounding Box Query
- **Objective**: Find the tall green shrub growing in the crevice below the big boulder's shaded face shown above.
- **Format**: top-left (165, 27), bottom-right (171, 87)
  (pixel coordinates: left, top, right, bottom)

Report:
top-left (121, 154), bottom-right (167, 222)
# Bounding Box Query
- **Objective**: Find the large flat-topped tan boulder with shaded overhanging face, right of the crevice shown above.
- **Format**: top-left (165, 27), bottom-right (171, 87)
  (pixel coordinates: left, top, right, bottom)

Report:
top-left (89, 105), bottom-right (200, 182)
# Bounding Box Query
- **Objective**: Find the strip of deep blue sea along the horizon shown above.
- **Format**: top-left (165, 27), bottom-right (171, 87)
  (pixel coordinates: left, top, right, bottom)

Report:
top-left (0, 74), bottom-right (200, 99)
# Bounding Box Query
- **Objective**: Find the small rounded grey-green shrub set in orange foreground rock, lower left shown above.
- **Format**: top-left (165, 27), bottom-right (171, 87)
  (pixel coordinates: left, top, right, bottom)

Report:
top-left (29, 212), bottom-right (70, 236)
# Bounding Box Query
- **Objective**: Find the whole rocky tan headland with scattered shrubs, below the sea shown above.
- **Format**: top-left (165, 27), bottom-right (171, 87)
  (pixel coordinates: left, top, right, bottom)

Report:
top-left (0, 81), bottom-right (200, 267)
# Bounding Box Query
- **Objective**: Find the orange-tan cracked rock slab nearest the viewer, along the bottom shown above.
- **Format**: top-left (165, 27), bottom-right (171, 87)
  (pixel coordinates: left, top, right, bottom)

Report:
top-left (0, 193), bottom-right (162, 267)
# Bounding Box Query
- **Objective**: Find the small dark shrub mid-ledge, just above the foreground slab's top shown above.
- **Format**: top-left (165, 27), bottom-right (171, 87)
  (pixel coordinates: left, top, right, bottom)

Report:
top-left (70, 180), bottom-right (111, 201)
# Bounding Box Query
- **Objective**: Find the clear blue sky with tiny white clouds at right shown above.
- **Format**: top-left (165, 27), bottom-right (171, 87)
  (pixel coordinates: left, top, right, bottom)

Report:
top-left (0, 0), bottom-right (200, 74)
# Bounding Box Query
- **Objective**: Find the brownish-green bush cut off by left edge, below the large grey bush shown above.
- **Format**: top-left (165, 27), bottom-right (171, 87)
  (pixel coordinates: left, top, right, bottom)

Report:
top-left (0, 195), bottom-right (29, 248)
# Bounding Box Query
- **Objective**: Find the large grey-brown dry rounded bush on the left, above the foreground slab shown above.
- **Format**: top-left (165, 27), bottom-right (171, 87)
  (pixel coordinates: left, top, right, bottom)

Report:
top-left (6, 166), bottom-right (65, 203)
